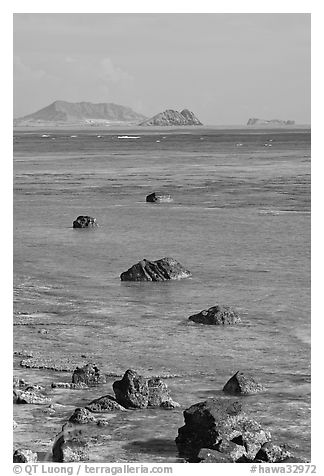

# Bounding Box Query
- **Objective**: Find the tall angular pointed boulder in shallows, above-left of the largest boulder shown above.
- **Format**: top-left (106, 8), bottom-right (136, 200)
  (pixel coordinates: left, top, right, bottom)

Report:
top-left (113, 369), bottom-right (149, 408)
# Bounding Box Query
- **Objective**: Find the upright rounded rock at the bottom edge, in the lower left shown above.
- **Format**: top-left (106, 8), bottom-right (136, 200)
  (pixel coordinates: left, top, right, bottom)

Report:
top-left (52, 422), bottom-right (89, 463)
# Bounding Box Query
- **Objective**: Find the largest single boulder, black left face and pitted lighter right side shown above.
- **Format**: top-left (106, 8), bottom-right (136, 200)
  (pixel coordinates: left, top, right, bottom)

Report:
top-left (175, 399), bottom-right (271, 461)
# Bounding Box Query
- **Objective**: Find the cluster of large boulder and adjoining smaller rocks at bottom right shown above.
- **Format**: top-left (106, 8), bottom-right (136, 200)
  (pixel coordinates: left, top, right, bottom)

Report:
top-left (175, 398), bottom-right (291, 463)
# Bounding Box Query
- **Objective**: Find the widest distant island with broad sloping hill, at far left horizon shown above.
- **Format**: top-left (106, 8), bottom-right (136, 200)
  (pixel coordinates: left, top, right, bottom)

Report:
top-left (14, 101), bottom-right (146, 126)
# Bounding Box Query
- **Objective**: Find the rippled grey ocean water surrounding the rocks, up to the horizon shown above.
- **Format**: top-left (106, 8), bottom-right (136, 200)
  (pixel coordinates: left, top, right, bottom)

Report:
top-left (14, 128), bottom-right (311, 462)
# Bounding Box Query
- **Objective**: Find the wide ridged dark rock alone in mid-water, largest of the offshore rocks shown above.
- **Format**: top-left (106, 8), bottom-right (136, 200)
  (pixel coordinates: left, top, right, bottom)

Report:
top-left (120, 258), bottom-right (191, 281)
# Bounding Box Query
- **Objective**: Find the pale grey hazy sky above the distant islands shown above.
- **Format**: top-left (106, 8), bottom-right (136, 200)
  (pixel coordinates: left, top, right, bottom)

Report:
top-left (14, 13), bottom-right (311, 125)
